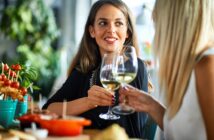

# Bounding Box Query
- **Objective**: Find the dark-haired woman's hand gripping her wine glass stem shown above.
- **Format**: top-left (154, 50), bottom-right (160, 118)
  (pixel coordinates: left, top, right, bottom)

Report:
top-left (87, 85), bottom-right (115, 107)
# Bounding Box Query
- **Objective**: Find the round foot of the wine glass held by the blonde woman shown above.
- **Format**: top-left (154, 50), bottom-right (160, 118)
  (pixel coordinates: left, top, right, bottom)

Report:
top-left (112, 105), bottom-right (135, 115)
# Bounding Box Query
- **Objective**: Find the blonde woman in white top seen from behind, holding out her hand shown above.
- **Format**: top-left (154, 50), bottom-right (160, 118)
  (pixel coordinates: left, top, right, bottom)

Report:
top-left (120, 0), bottom-right (214, 140)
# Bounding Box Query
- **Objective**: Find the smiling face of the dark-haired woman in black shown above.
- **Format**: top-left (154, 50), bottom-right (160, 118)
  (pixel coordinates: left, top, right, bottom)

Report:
top-left (89, 4), bottom-right (128, 56)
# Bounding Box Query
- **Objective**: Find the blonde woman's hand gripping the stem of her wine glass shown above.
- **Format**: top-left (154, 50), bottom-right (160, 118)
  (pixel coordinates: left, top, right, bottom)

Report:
top-left (119, 85), bottom-right (154, 113)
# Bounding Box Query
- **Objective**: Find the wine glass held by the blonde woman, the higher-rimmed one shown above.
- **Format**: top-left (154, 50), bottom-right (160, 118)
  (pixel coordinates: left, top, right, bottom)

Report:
top-left (112, 46), bottom-right (138, 115)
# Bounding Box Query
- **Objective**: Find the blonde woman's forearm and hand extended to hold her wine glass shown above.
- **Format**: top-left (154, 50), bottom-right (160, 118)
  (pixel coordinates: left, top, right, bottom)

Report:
top-left (120, 85), bottom-right (165, 128)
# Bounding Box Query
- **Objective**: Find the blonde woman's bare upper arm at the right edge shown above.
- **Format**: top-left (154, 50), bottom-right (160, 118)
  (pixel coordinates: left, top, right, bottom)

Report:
top-left (195, 55), bottom-right (214, 140)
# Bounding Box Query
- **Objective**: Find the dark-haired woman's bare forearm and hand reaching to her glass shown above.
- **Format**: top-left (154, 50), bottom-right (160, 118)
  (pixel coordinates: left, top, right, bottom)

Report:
top-left (47, 85), bottom-right (114, 115)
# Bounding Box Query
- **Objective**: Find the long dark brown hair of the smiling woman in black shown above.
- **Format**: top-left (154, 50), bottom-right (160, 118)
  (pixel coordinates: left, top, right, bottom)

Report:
top-left (68, 0), bottom-right (139, 75)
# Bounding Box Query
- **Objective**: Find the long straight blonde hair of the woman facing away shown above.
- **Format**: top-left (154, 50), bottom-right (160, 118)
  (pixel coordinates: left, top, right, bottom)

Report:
top-left (153, 0), bottom-right (214, 118)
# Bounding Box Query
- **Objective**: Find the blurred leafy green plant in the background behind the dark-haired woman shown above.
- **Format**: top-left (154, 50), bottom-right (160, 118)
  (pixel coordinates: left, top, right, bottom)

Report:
top-left (0, 0), bottom-right (59, 97)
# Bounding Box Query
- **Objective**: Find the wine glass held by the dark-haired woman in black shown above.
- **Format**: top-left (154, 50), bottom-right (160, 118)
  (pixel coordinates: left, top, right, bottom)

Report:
top-left (99, 53), bottom-right (120, 120)
